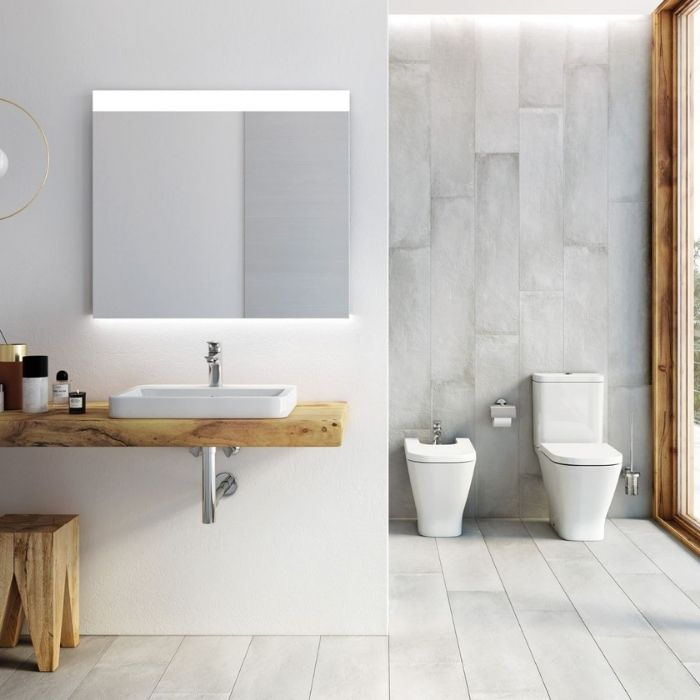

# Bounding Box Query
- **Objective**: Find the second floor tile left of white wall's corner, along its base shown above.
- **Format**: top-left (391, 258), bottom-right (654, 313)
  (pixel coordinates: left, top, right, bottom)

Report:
top-left (231, 637), bottom-right (319, 700)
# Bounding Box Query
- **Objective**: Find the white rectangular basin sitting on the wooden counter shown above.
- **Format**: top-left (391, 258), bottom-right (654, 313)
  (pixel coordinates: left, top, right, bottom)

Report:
top-left (109, 384), bottom-right (297, 418)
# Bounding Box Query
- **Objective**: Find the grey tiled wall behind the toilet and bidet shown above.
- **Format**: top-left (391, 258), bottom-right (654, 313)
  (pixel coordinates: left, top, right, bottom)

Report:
top-left (389, 16), bottom-right (651, 517)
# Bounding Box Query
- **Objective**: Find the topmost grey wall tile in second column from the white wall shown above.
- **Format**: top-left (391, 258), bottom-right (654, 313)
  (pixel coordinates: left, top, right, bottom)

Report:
top-left (430, 17), bottom-right (475, 197)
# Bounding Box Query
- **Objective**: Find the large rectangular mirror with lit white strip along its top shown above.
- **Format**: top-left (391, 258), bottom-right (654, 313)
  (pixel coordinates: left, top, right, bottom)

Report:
top-left (93, 90), bottom-right (349, 318)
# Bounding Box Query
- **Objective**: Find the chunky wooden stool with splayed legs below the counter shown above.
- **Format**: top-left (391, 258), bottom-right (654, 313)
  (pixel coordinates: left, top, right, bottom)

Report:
top-left (0, 515), bottom-right (80, 671)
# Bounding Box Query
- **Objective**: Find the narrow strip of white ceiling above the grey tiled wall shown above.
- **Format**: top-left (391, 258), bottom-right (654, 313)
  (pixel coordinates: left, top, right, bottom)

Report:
top-left (389, 0), bottom-right (661, 15)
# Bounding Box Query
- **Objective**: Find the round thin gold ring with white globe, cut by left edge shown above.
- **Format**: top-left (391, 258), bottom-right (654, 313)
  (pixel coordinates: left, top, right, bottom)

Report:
top-left (0, 97), bottom-right (49, 221)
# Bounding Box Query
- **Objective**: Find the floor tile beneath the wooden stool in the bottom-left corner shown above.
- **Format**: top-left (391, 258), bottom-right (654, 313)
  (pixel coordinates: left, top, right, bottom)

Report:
top-left (0, 637), bottom-right (115, 700)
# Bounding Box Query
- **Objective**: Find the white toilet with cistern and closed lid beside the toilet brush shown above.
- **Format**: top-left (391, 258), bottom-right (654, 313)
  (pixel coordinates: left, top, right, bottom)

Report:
top-left (532, 372), bottom-right (622, 540)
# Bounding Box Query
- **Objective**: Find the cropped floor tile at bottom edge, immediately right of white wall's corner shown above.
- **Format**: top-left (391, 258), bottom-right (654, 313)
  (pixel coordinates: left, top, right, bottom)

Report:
top-left (391, 664), bottom-right (473, 700)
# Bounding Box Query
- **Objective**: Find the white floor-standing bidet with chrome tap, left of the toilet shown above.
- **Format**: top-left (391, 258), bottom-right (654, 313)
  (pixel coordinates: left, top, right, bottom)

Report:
top-left (404, 438), bottom-right (476, 537)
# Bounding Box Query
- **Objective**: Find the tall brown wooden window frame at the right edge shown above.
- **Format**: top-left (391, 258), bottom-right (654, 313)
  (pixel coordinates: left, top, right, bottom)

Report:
top-left (651, 0), bottom-right (700, 554)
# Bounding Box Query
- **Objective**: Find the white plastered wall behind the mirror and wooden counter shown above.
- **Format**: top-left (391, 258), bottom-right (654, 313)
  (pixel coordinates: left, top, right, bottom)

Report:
top-left (0, 0), bottom-right (387, 634)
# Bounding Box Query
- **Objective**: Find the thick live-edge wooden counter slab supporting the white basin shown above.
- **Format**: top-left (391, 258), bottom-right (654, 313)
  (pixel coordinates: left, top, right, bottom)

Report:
top-left (0, 402), bottom-right (347, 447)
